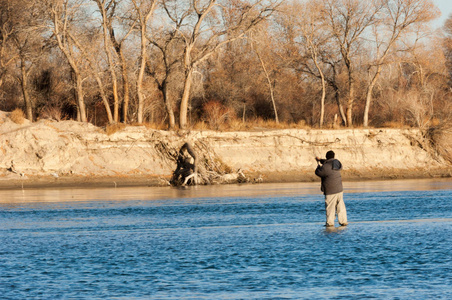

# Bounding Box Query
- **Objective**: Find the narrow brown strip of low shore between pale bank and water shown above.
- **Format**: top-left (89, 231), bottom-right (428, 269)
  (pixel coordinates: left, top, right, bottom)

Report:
top-left (0, 167), bottom-right (452, 190)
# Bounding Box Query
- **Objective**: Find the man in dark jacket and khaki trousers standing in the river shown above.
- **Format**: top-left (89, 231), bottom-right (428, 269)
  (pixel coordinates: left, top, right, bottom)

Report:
top-left (315, 150), bottom-right (348, 227)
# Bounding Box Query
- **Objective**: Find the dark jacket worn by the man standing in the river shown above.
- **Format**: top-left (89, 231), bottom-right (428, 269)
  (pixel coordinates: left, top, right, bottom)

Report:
top-left (315, 158), bottom-right (344, 195)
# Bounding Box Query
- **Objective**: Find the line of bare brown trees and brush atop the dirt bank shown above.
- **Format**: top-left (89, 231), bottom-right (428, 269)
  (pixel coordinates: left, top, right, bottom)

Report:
top-left (0, 0), bottom-right (452, 129)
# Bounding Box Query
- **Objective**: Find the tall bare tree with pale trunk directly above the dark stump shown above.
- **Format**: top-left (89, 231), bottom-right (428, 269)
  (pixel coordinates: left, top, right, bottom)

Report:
top-left (163, 0), bottom-right (281, 128)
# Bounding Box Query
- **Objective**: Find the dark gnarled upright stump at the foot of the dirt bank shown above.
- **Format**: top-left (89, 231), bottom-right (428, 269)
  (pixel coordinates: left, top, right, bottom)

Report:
top-left (170, 143), bottom-right (198, 185)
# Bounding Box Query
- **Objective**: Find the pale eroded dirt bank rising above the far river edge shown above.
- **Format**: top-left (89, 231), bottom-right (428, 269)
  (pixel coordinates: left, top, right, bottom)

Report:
top-left (0, 113), bottom-right (452, 188)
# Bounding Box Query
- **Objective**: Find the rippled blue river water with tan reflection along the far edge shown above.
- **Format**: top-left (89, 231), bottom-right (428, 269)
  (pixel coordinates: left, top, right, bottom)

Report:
top-left (0, 179), bottom-right (452, 299)
